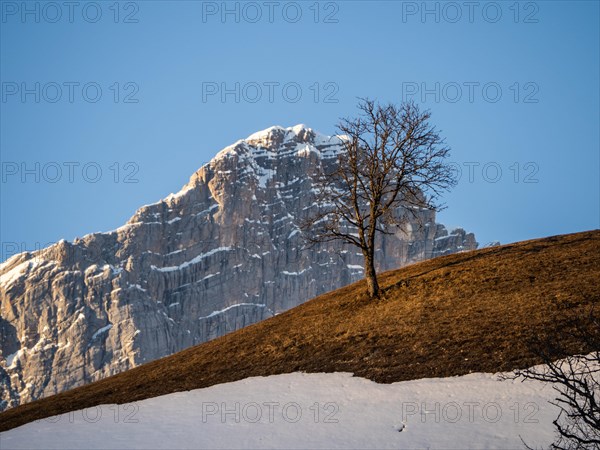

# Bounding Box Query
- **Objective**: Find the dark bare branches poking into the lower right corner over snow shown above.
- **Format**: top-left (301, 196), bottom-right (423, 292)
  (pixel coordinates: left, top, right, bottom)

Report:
top-left (514, 309), bottom-right (600, 450)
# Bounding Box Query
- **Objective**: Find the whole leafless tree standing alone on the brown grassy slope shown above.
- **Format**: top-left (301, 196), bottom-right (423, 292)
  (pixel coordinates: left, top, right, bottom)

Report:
top-left (302, 99), bottom-right (455, 298)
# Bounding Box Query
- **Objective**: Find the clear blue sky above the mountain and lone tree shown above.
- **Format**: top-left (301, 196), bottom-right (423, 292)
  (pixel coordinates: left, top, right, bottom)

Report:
top-left (0, 1), bottom-right (600, 259)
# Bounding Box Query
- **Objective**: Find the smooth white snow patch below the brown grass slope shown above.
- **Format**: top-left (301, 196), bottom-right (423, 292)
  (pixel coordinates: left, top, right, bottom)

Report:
top-left (0, 373), bottom-right (558, 449)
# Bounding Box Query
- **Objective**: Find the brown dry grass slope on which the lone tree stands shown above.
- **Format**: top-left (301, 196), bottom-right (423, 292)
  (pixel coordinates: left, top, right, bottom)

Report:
top-left (0, 230), bottom-right (600, 431)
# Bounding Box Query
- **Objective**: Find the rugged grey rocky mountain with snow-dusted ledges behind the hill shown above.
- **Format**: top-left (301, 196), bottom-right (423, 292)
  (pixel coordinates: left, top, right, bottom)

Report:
top-left (0, 125), bottom-right (477, 409)
